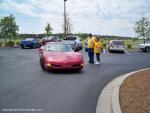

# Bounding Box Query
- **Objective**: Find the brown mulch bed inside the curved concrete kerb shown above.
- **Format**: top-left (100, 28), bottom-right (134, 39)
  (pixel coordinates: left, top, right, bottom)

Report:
top-left (119, 70), bottom-right (150, 113)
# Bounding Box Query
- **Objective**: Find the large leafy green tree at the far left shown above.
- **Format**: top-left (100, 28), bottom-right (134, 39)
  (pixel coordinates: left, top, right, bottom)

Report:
top-left (0, 15), bottom-right (19, 44)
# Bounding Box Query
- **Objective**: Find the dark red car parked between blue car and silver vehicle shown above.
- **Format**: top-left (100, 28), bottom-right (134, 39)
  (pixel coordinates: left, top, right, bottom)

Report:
top-left (40, 36), bottom-right (61, 46)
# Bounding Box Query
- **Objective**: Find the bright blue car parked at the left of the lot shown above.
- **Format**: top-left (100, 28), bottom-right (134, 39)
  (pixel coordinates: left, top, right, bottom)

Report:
top-left (20, 38), bottom-right (40, 48)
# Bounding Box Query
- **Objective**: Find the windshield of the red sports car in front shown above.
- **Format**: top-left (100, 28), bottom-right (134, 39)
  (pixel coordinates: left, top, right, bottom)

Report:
top-left (45, 43), bottom-right (73, 52)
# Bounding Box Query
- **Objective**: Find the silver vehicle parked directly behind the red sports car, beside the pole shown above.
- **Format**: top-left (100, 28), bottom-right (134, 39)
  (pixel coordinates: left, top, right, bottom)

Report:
top-left (63, 36), bottom-right (83, 51)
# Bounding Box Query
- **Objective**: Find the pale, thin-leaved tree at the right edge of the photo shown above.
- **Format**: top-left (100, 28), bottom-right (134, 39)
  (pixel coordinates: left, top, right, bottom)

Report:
top-left (134, 17), bottom-right (150, 44)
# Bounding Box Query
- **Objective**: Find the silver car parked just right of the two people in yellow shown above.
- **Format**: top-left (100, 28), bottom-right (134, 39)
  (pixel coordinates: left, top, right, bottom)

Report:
top-left (108, 40), bottom-right (125, 52)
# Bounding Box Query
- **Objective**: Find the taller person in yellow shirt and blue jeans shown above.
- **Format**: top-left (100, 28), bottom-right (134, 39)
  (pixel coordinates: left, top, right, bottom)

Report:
top-left (88, 34), bottom-right (95, 64)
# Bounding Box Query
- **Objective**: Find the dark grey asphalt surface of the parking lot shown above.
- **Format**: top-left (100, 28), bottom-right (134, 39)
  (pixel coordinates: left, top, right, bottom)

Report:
top-left (0, 48), bottom-right (150, 113)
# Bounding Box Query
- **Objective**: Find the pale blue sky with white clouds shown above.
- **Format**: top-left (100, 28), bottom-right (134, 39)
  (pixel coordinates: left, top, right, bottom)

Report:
top-left (0, 0), bottom-right (150, 36)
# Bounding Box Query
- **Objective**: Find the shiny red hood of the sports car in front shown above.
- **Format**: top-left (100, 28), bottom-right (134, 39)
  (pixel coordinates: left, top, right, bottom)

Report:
top-left (45, 52), bottom-right (82, 62)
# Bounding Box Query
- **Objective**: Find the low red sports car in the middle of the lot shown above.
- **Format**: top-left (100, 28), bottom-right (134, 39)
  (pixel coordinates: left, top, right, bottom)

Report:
top-left (39, 42), bottom-right (84, 70)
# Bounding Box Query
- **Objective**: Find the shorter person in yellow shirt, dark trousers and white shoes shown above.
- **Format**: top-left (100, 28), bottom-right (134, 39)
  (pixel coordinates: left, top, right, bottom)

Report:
top-left (94, 37), bottom-right (102, 64)
